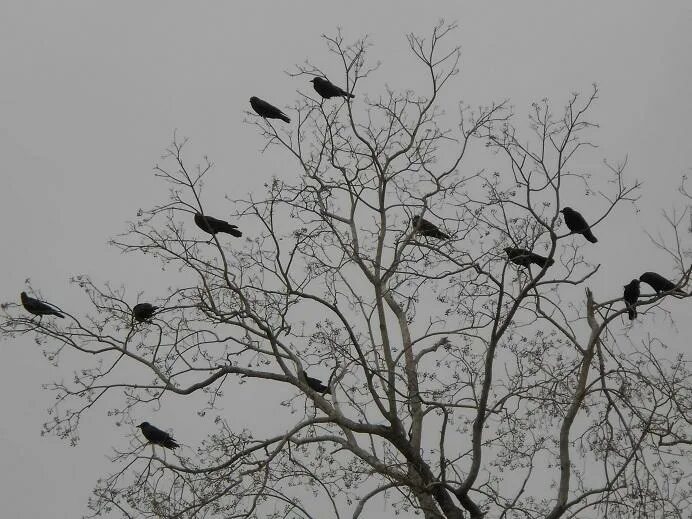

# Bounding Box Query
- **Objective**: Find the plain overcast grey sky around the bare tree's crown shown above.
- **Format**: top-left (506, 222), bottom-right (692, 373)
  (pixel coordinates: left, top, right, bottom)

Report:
top-left (0, 0), bottom-right (692, 519)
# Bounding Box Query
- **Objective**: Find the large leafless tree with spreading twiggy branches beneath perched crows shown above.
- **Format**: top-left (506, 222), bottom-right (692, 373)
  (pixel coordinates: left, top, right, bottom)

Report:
top-left (2, 24), bottom-right (692, 519)
